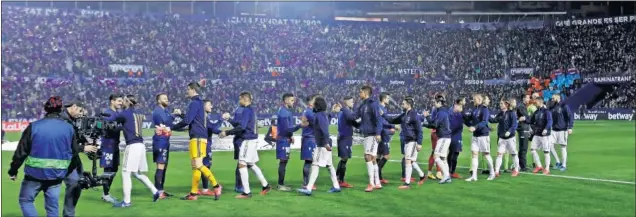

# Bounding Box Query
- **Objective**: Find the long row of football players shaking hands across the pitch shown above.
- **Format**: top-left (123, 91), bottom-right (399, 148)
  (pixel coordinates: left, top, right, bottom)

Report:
top-left (92, 82), bottom-right (573, 207)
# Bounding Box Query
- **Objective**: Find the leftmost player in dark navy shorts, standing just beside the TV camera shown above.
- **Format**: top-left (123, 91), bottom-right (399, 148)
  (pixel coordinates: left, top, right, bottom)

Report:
top-left (99, 94), bottom-right (124, 204)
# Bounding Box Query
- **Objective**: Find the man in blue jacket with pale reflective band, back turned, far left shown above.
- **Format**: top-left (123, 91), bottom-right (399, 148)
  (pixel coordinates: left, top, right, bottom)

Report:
top-left (9, 96), bottom-right (81, 216)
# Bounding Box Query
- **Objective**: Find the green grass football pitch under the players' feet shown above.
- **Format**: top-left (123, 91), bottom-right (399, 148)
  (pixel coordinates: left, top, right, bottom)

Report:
top-left (1, 121), bottom-right (636, 216)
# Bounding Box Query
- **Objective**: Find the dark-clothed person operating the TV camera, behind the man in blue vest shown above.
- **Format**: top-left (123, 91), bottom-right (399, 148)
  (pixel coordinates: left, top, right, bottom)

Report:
top-left (60, 101), bottom-right (97, 216)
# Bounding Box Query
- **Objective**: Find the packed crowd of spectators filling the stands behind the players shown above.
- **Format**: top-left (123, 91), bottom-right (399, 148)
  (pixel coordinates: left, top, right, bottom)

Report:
top-left (2, 7), bottom-right (636, 119)
